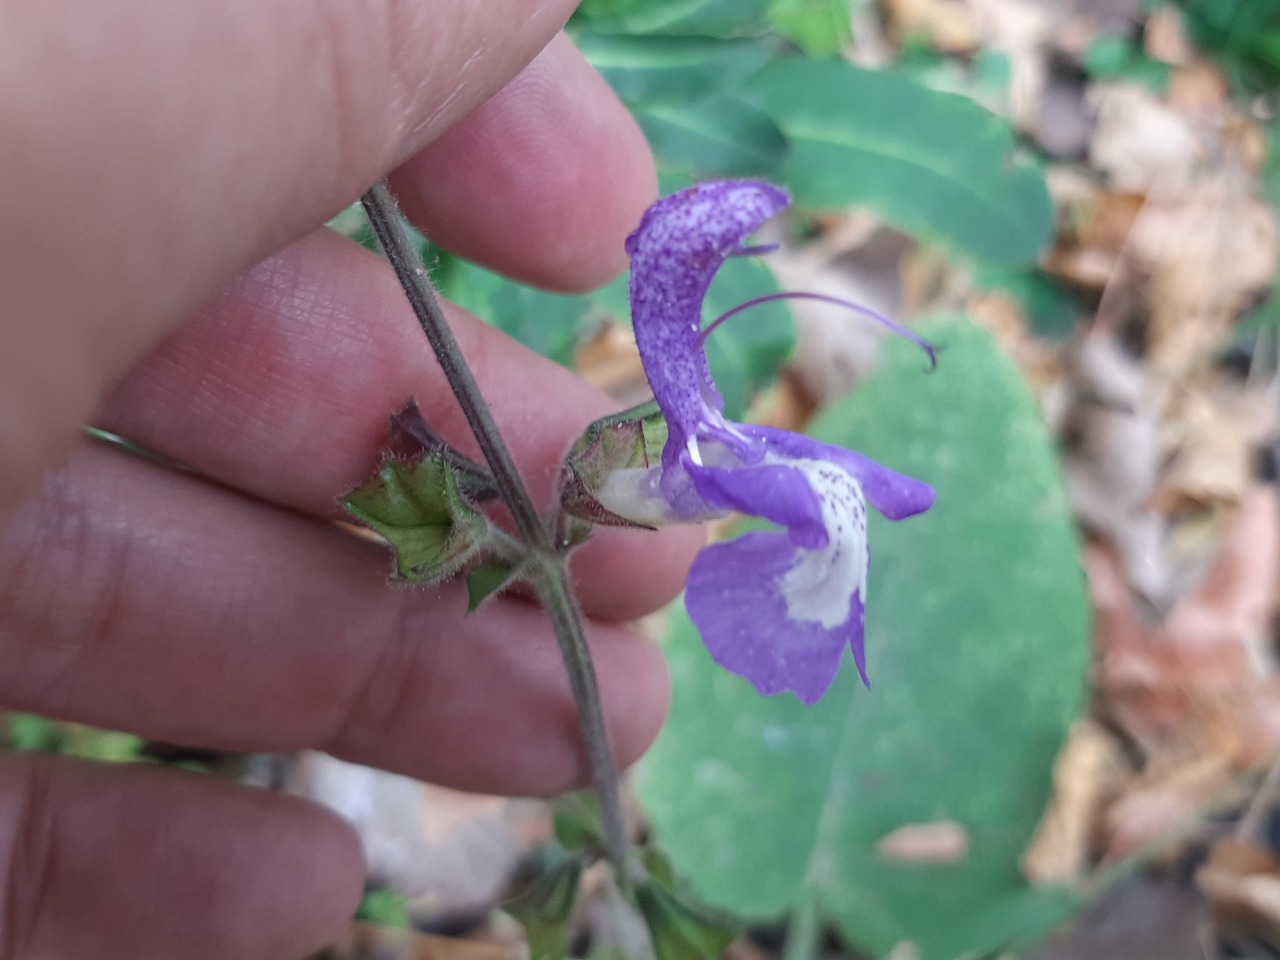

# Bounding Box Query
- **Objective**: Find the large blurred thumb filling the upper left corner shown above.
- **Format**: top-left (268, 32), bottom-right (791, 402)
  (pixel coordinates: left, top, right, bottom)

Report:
top-left (0, 0), bottom-right (573, 512)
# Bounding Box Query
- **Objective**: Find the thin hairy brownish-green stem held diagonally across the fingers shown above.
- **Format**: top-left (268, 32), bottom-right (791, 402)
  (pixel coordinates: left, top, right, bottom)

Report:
top-left (361, 183), bottom-right (627, 886)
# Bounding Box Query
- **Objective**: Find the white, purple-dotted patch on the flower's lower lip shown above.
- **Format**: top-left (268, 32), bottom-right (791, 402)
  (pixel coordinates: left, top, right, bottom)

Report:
top-left (778, 460), bottom-right (867, 630)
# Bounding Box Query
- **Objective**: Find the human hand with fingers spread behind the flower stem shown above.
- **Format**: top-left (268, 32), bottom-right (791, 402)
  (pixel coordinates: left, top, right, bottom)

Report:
top-left (0, 0), bottom-right (698, 960)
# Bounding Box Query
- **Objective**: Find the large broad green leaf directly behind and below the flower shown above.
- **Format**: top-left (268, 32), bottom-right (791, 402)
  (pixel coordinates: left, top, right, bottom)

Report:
top-left (637, 321), bottom-right (1091, 960)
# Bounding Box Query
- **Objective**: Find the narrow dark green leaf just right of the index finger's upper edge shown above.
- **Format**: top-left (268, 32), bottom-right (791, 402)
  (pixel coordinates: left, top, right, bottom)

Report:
top-left (577, 33), bottom-right (771, 108)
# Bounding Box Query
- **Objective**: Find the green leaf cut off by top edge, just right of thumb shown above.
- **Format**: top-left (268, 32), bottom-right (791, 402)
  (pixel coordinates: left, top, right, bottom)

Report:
top-left (576, 0), bottom-right (769, 37)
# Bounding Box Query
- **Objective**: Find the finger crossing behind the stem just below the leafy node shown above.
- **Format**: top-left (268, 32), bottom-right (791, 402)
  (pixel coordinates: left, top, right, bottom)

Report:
top-left (0, 448), bottom-right (668, 794)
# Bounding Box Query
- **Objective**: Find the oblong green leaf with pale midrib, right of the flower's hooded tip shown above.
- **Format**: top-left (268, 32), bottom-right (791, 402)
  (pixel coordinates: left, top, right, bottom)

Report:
top-left (748, 59), bottom-right (1052, 264)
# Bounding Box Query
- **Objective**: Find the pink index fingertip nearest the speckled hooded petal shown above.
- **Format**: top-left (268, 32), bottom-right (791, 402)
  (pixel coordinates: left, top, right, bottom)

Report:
top-left (392, 35), bottom-right (658, 291)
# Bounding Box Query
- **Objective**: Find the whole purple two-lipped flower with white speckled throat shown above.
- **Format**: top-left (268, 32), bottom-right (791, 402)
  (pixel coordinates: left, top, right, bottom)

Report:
top-left (599, 180), bottom-right (933, 703)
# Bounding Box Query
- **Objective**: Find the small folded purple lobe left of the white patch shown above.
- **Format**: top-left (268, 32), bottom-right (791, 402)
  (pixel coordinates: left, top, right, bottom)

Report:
top-left (689, 466), bottom-right (828, 547)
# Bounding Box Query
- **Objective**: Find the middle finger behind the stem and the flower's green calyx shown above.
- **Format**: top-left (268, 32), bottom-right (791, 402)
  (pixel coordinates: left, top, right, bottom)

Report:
top-left (99, 232), bottom-right (701, 620)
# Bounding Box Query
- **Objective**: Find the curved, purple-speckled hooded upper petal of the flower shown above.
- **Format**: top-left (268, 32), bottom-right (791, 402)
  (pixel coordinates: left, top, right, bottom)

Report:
top-left (627, 180), bottom-right (790, 436)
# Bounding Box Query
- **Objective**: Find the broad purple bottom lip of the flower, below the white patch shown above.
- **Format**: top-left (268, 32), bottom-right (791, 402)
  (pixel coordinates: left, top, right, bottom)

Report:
top-left (685, 532), bottom-right (867, 704)
